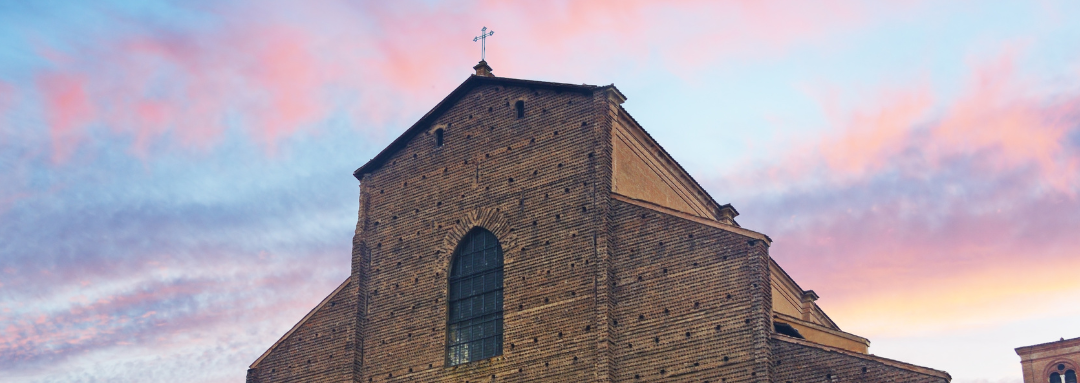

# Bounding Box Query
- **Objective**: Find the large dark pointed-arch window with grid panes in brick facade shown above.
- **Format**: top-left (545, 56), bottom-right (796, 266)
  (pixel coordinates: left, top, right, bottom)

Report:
top-left (446, 228), bottom-right (502, 366)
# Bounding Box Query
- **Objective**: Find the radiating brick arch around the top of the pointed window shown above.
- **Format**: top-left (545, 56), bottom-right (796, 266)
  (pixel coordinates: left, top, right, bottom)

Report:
top-left (435, 207), bottom-right (517, 272)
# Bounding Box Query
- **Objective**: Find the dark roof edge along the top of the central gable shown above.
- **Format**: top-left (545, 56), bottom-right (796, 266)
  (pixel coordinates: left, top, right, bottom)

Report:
top-left (352, 74), bottom-right (609, 180)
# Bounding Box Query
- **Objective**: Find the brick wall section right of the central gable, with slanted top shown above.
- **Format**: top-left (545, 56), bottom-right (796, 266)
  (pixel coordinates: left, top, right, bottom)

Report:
top-left (613, 201), bottom-right (770, 382)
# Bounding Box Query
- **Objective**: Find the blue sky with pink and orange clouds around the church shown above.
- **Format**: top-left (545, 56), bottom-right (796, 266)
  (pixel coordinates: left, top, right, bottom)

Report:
top-left (0, 0), bottom-right (1080, 383)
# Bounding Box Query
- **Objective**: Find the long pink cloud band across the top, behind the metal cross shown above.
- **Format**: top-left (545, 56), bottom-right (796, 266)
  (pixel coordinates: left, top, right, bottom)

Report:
top-left (25, 1), bottom-right (937, 161)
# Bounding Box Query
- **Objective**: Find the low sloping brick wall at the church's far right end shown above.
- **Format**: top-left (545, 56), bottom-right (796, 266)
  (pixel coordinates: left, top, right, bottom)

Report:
top-left (772, 336), bottom-right (950, 383)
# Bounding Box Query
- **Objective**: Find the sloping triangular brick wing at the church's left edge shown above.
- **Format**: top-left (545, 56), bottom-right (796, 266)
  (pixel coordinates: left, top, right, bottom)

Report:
top-left (247, 281), bottom-right (356, 383)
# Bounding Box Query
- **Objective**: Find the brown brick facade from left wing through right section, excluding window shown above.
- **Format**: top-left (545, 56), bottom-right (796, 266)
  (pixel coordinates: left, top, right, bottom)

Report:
top-left (248, 78), bottom-right (950, 383)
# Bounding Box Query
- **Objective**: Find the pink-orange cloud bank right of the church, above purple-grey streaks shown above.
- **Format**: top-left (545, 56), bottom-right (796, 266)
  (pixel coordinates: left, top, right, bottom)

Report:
top-left (717, 54), bottom-right (1080, 195)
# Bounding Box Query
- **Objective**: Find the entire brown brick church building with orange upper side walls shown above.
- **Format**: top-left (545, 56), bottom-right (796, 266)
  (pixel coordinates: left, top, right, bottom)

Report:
top-left (247, 61), bottom-right (950, 383)
